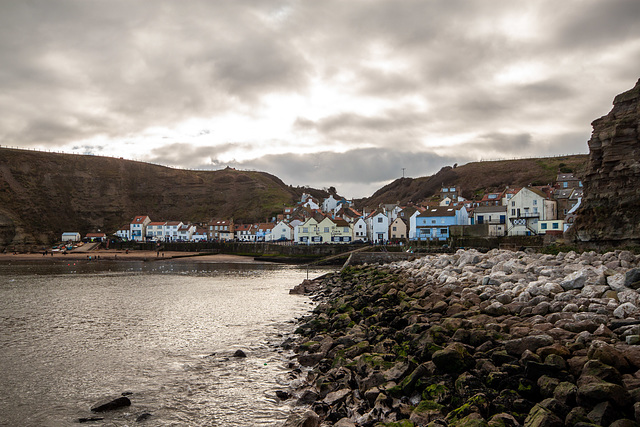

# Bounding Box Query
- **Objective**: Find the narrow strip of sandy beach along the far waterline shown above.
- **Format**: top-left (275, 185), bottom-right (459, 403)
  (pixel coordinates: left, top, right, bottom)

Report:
top-left (0, 249), bottom-right (265, 264)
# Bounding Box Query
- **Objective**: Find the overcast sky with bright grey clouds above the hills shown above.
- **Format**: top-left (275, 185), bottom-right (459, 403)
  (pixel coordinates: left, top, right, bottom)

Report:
top-left (0, 0), bottom-right (640, 197)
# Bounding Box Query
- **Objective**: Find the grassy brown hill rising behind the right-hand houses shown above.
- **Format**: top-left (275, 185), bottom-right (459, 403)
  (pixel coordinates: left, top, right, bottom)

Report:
top-left (357, 154), bottom-right (588, 207)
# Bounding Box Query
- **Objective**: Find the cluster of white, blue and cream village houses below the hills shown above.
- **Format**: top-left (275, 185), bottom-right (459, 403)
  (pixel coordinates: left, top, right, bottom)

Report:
top-left (62, 173), bottom-right (583, 245)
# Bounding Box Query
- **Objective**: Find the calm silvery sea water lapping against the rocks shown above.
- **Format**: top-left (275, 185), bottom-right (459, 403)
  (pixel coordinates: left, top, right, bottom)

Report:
top-left (0, 262), bottom-right (326, 426)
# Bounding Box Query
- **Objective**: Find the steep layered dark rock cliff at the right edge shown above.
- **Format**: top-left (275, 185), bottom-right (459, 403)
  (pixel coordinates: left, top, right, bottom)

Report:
top-left (575, 80), bottom-right (640, 244)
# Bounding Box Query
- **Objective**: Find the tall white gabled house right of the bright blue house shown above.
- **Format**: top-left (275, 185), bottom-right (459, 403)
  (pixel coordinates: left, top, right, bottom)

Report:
top-left (507, 187), bottom-right (557, 236)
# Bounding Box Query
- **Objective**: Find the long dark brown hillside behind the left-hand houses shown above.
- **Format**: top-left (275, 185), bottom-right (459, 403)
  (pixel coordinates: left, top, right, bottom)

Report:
top-left (0, 148), bottom-right (328, 250)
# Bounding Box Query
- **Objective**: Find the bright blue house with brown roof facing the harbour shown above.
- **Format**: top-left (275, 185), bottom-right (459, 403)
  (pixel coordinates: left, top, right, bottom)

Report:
top-left (416, 206), bottom-right (469, 240)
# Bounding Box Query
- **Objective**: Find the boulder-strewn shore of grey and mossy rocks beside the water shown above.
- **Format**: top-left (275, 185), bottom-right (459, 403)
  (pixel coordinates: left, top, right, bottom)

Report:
top-left (282, 250), bottom-right (640, 427)
